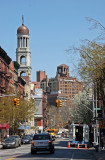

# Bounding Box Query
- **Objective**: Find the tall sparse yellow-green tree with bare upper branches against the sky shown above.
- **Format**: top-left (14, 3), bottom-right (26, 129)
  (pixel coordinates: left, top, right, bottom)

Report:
top-left (66, 18), bottom-right (105, 118)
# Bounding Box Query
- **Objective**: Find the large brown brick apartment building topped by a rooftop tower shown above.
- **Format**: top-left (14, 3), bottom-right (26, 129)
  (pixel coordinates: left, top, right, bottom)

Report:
top-left (48, 64), bottom-right (82, 105)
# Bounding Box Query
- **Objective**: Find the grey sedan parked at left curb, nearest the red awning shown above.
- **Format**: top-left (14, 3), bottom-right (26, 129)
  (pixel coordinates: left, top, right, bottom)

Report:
top-left (2, 137), bottom-right (19, 148)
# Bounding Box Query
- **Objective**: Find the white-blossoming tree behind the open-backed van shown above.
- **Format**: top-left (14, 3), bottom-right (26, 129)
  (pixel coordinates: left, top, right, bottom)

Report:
top-left (71, 91), bottom-right (93, 125)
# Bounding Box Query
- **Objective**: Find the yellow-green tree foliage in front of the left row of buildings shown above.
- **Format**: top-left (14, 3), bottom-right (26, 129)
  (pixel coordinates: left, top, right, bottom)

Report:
top-left (0, 92), bottom-right (35, 131)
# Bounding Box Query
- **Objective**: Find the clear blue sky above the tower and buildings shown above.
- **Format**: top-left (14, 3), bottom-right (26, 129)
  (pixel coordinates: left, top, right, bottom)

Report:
top-left (0, 0), bottom-right (105, 81)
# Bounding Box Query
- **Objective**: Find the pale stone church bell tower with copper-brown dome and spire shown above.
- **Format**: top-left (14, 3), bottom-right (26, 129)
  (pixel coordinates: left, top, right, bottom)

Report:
top-left (16, 16), bottom-right (31, 98)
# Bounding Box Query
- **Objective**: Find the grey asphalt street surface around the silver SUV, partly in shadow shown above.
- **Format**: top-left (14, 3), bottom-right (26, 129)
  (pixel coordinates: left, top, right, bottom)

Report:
top-left (0, 138), bottom-right (95, 160)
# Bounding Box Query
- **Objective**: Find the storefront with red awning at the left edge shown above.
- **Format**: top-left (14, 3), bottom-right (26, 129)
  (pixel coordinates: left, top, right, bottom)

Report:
top-left (0, 123), bottom-right (9, 142)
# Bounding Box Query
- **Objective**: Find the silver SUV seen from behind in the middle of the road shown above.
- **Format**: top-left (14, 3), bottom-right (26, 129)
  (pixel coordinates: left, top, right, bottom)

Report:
top-left (31, 133), bottom-right (54, 154)
